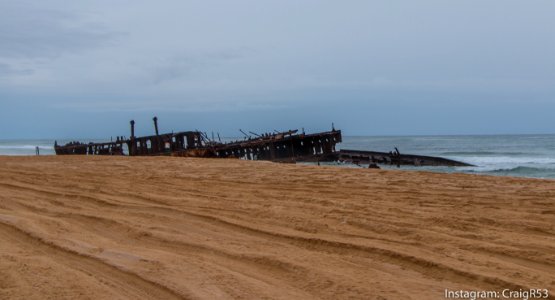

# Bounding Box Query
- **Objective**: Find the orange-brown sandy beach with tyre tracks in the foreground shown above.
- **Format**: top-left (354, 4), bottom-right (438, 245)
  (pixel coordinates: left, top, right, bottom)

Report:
top-left (0, 156), bottom-right (555, 299)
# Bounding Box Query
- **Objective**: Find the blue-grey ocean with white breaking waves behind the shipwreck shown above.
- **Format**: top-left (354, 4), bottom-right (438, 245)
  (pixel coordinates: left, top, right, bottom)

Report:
top-left (0, 135), bottom-right (555, 178)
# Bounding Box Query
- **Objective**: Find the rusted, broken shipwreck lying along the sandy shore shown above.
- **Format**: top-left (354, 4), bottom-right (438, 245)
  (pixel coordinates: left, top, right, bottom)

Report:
top-left (54, 117), bottom-right (471, 167)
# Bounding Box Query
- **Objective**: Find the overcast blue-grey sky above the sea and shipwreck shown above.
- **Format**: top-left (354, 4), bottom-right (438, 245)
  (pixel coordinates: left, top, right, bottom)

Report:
top-left (0, 0), bottom-right (555, 139)
